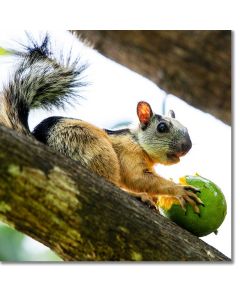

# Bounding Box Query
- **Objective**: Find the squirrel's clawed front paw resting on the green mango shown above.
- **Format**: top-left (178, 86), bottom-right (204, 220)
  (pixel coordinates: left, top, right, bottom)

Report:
top-left (174, 185), bottom-right (204, 214)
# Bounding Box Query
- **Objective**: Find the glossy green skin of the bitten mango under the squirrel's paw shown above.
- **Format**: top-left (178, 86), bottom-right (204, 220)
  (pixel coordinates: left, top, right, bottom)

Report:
top-left (159, 175), bottom-right (227, 237)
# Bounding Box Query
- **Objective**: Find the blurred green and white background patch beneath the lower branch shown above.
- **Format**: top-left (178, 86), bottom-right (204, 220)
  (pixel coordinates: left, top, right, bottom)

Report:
top-left (0, 223), bottom-right (61, 262)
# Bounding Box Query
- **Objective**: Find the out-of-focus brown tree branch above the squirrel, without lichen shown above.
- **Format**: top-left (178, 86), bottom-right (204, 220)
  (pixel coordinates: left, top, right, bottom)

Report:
top-left (76, 30), bottom-right (231, 124)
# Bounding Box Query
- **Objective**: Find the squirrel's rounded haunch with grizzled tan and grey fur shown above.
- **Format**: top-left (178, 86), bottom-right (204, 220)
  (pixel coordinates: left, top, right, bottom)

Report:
top-left (47, 119), bottom-right (120, 185)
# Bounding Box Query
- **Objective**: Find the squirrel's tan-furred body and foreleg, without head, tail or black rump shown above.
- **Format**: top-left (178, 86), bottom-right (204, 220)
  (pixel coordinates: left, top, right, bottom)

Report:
top-left (43, 118), bottom-right (202, 210)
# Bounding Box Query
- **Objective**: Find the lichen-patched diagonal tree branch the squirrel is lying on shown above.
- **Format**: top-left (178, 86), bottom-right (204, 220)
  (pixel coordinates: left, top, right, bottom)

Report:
top-left (0, 126), bottom-right (230, 261)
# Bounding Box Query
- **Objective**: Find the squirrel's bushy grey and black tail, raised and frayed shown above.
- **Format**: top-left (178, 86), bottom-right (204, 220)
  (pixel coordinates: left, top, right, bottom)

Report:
top-left (0, 34), bottom-right (87, 134)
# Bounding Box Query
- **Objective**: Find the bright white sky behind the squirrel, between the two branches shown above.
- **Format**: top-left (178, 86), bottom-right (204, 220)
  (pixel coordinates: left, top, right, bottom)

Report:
top-left (0, 31), bottom-right (231, 257)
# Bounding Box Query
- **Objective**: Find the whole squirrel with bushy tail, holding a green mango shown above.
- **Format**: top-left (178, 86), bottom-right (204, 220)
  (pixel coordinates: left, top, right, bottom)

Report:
top-left (0, 34), bottom-right (202, 213)
